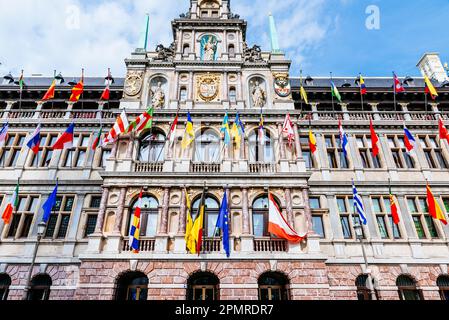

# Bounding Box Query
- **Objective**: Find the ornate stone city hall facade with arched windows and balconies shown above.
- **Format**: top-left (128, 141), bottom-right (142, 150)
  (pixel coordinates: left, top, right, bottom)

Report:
top-left (0, 0), bottom-right (449, 300)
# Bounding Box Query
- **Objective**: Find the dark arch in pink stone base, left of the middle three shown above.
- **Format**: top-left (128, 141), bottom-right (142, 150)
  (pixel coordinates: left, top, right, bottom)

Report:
top-left (115, 272), bottom-right (148, 301)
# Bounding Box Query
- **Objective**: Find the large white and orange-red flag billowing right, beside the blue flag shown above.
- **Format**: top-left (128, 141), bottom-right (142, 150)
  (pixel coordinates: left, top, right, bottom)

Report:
top-left (268, 193), bottom-right (306, 243)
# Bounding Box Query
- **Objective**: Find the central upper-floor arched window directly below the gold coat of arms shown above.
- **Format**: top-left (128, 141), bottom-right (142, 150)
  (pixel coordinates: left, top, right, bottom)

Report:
top-left (193, 129), bottom-right (221, 163)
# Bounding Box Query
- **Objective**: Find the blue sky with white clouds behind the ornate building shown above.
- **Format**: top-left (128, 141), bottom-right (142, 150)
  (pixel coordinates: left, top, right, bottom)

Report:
top-left (0, 0), bottom-right (449, 77)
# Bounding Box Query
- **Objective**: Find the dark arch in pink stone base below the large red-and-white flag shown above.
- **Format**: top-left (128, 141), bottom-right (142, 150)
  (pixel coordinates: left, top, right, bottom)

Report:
top-left (258, 272), bottom-right (289, 301)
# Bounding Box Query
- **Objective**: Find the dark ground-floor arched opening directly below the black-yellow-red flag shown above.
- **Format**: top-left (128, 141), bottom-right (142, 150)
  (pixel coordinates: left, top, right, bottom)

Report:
top-left (187, 272), bottom-right (220, 301)
